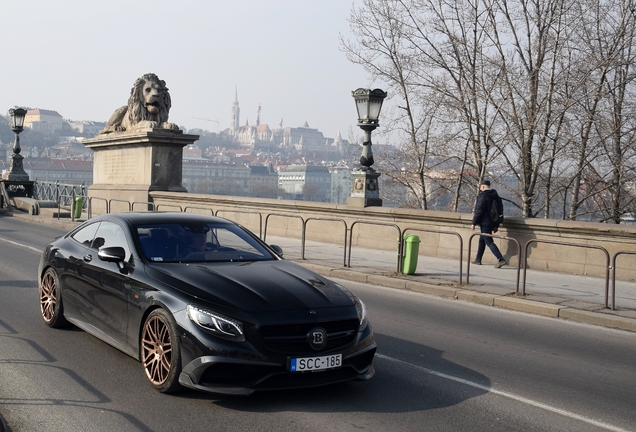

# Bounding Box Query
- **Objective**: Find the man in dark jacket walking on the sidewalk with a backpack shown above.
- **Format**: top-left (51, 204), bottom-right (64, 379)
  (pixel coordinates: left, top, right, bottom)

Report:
top-left (470, 180), bottom-right (508, 268)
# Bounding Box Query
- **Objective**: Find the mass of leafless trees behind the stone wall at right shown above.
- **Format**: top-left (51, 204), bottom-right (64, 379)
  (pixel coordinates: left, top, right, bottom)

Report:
top-left (342, 0), bottom-right (636, 223)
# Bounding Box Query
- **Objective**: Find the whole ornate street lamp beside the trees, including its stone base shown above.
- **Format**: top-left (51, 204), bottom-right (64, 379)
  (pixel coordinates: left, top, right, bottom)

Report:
top-left (347, 88), bottom-right (387, 207)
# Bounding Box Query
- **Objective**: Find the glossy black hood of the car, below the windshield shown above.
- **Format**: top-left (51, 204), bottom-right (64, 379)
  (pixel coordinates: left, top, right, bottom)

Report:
top-left (146, 260), bottom-right (354, 312)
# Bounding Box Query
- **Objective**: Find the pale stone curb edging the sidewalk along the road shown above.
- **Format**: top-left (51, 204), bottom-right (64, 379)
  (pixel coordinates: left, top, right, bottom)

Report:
top-left (294, 261), bottom-right (636, 332)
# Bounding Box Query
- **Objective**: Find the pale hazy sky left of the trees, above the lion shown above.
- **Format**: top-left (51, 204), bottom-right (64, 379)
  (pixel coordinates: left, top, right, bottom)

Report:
top-left (0, 0), bottom-right (373, 140)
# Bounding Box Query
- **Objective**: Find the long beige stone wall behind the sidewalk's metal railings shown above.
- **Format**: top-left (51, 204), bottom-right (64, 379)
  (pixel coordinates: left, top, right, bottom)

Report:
top-left (150, 192), bottom-right (636, 280)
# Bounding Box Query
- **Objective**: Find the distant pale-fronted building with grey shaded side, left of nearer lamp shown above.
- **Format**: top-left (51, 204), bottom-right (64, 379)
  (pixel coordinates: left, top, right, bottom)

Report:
top-left (278, 165), bottom-right (331, 202)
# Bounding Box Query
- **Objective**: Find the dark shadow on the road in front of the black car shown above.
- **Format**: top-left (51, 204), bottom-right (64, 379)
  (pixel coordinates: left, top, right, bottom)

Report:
top-left (201, 334), bottom-right (490, 413)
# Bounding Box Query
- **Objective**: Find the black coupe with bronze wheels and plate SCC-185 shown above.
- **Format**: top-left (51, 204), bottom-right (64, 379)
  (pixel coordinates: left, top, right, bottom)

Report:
top-left (38, 212), bottom-right (377, 394)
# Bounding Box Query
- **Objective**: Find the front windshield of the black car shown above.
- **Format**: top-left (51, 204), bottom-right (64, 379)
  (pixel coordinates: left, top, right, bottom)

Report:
top-left (136, 223), bottom-right (276, 262)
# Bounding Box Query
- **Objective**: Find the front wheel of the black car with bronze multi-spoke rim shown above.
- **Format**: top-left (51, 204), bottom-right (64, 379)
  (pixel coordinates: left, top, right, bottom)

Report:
top-left (141, 309), bottom-right (182, 393)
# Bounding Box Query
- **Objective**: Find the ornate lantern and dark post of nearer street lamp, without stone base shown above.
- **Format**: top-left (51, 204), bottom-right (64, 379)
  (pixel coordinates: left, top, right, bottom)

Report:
top-left (351, 88), bottom-right (386, 171)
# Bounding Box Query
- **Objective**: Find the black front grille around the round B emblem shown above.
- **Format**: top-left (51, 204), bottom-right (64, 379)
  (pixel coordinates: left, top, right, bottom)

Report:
top-left (260, 319), bottom-right (359, 355)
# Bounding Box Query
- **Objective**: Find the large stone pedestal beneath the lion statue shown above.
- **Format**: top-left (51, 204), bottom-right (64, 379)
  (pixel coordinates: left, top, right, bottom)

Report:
top-left (83, 129), bottom-right (199, 214)
